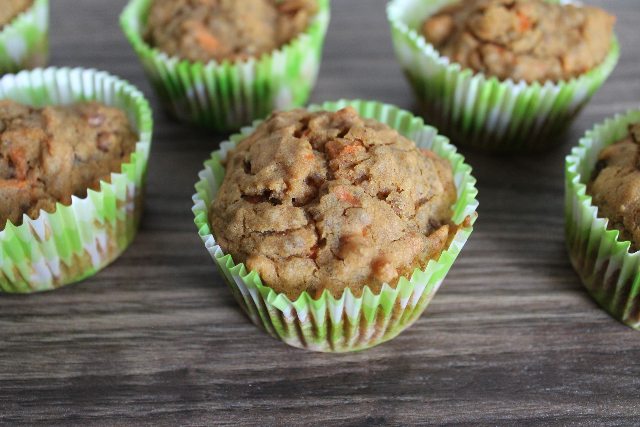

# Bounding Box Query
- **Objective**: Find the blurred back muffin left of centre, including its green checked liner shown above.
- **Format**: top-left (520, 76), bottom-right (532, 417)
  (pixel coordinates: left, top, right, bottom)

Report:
top-left (121, 0), bottom-right (329, 132)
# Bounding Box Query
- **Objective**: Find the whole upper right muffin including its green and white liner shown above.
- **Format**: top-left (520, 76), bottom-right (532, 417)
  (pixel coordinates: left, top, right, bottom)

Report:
top-left (388, 0), bottom-right (619, 151)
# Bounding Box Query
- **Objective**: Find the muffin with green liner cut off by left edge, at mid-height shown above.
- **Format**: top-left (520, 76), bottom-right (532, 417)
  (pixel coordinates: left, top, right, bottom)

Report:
top-left (0, 68), bottom-right (152, 293)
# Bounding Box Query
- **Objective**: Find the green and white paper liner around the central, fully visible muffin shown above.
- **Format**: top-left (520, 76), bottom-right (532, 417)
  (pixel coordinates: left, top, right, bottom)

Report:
top-left (193, 100), bottom-right (478, 352)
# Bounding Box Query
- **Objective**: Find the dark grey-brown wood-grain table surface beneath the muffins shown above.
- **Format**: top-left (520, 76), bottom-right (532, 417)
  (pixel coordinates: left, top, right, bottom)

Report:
top-left (0, 0), bottom-right (640, 425)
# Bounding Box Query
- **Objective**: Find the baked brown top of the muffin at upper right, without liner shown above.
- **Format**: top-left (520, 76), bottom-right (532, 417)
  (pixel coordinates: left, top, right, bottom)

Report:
top-left (422, 0), bottom-right (615, 83)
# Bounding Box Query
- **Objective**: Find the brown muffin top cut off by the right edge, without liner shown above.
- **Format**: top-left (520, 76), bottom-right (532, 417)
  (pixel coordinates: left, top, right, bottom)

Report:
top-left (587, 123), bottom-right (640, 250)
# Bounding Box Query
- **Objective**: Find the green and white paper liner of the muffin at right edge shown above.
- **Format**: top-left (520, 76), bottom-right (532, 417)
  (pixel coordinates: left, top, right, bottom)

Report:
top-left (565, 110), bottom-right (640, 329)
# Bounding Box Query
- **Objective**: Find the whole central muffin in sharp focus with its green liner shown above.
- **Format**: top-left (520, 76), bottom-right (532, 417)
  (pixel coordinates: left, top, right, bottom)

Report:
top-left (193, 101), bottom-right (477, 351)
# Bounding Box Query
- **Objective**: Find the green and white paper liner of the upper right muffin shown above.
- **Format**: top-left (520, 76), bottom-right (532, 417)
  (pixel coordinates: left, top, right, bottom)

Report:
top-left (387, 0), bottom-right (620, 152)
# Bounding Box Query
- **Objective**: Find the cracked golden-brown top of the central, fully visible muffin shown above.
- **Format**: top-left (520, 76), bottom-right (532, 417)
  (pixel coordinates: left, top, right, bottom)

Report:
top-left (210, 107), bottom-right (456, 300)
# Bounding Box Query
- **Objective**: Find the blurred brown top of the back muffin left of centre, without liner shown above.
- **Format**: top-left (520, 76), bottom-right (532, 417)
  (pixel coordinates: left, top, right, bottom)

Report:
top-left (145, 0), bottom-right (317, 62)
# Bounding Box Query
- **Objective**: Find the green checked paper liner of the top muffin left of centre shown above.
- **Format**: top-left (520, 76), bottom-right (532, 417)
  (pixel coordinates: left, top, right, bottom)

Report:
top-left (120, 0), bottom-right (329, 132)
